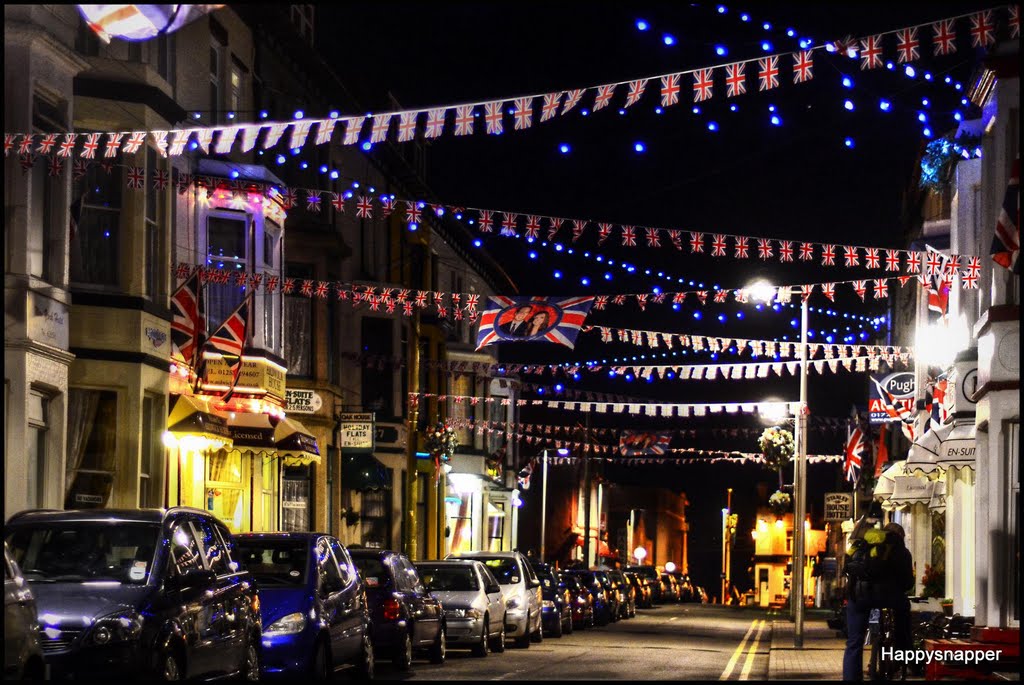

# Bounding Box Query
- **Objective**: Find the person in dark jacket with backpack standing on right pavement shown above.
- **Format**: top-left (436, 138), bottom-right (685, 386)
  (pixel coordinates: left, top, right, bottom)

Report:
top-left (843, 515), bottom-right (914, 681)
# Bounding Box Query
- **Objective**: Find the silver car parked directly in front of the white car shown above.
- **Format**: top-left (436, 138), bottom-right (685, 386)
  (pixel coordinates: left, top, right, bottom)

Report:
top-left (416, 561), bottom-right (505, 656)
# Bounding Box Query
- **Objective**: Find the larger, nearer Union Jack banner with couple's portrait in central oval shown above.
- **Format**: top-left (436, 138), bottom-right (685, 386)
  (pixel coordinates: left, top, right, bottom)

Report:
top-left (476, 296), bottom-right (594, 350)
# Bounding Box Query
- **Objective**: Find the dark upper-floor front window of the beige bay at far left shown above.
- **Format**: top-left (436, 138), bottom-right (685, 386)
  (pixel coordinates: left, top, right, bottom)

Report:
top-left (71, 154), bottom-right (123, 287)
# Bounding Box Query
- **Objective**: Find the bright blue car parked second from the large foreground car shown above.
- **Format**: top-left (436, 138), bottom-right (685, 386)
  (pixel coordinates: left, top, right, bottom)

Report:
top-left (234, 532), bottom-right (374, 680)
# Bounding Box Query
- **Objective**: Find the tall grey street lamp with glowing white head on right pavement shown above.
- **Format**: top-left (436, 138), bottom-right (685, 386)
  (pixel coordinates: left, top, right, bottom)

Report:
top-left (746, 281), bottom-right (808, 649)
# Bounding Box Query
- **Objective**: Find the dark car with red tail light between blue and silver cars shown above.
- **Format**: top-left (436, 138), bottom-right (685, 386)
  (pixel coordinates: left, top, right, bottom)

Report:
top-left (348, 547), bottom-right (447, 671)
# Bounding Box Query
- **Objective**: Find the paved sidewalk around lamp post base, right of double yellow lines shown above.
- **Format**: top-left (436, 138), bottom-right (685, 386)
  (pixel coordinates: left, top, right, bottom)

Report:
top-left (768, 619), bottom-right (846, 681)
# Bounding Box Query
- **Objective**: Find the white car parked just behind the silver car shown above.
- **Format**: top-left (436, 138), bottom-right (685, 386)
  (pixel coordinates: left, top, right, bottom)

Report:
top-left (447, 550), bottom-right (544, 648)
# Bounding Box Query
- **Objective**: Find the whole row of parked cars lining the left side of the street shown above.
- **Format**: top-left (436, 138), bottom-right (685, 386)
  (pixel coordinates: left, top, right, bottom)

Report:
top-left (4, 501), bottom-right (688, 681)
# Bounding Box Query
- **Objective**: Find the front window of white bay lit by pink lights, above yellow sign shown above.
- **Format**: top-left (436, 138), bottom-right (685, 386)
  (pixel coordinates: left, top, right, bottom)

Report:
top-left (206, 212), bottom-right (249, 332)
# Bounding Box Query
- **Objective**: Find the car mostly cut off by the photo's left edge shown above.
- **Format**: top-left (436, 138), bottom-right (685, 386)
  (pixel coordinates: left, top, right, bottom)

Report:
top-left (3, 543), bottom-right (45, 680)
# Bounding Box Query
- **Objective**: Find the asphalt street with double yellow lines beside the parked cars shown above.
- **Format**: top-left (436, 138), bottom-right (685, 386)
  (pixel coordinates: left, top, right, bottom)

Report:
top-left (377, 604), bottom-right (771, 680)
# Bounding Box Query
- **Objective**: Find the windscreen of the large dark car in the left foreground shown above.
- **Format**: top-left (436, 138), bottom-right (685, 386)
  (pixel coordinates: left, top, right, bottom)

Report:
top-left (6, 520), bottom-right (160, 585)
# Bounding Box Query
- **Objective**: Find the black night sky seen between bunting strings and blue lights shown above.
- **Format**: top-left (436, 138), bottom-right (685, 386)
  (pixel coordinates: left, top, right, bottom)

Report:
top-left (317, 2), bottom-right (1002, 587)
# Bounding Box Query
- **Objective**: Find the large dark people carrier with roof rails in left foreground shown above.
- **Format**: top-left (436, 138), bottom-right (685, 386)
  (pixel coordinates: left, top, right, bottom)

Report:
top-left (4, 507), bottom-right (261, 682)
